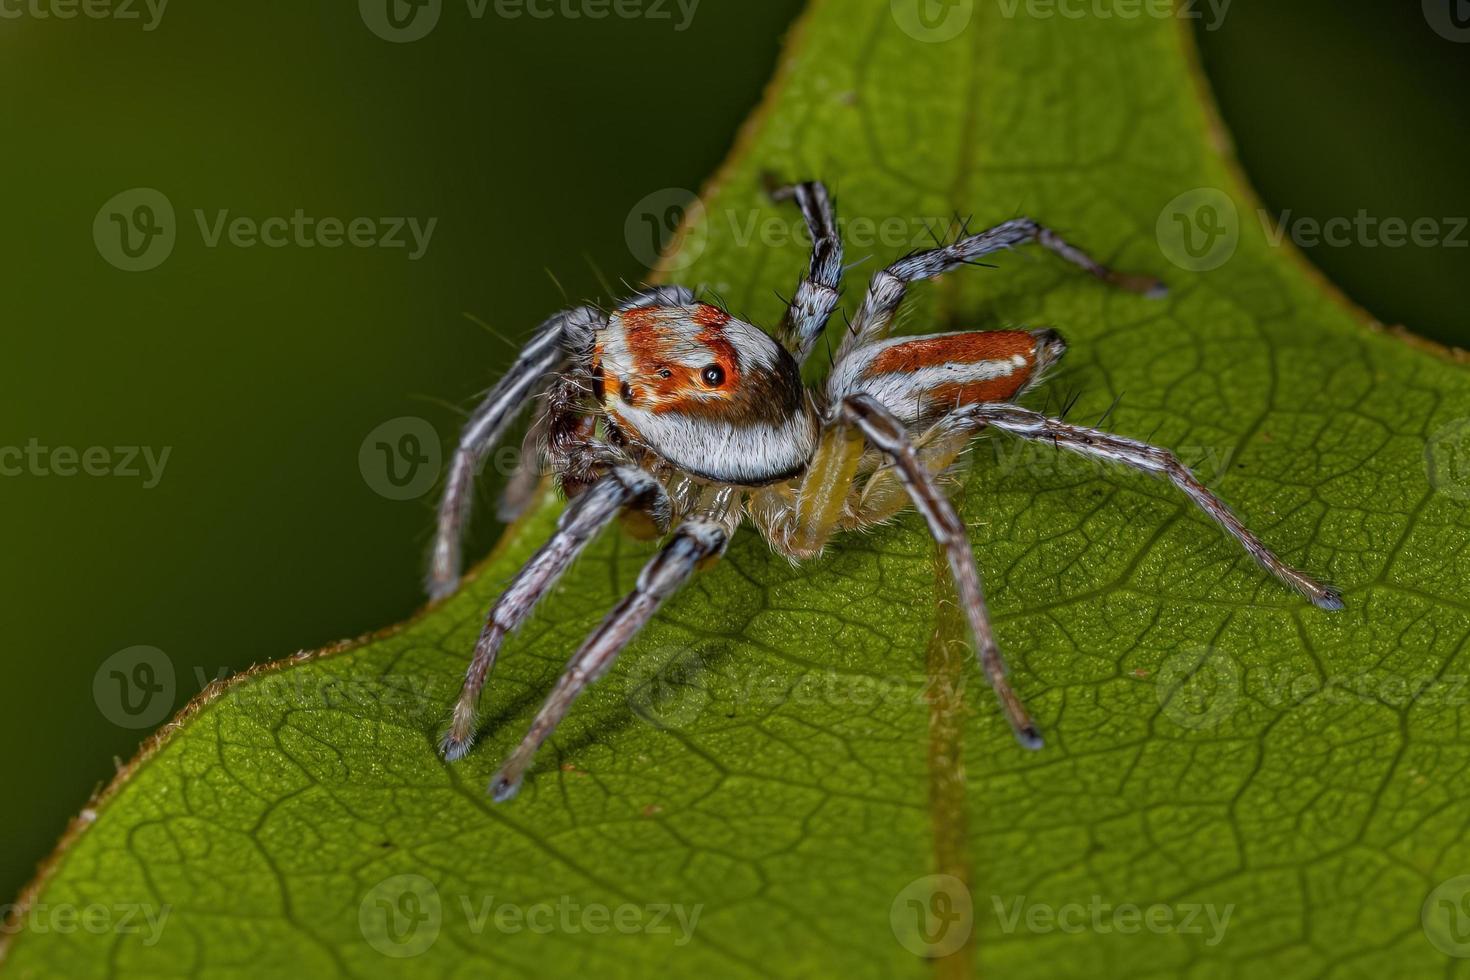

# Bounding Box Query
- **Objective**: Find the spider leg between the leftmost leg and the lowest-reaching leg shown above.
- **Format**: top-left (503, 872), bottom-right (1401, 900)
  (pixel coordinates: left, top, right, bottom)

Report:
top-left (440, 467), bottom-right (669, 761)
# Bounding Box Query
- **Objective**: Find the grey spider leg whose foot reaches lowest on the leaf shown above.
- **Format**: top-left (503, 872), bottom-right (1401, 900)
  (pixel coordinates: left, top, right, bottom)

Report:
top-left (490, 516), bottom-right (731, 802)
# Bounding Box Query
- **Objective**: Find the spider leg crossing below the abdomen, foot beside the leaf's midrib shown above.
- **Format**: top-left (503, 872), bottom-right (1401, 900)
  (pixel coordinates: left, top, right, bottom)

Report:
top-left (842, 394), bottom-right (1042, 749)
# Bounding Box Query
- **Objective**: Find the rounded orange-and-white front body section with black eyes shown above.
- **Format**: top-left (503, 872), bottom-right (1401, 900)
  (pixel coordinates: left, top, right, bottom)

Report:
top-left (592, 303), bottom-right (817, 486)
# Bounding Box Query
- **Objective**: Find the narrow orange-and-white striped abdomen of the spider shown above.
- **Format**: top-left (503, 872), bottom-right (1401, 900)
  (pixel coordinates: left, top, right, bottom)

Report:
top-left (828, 331), bottom-right (1067, 426)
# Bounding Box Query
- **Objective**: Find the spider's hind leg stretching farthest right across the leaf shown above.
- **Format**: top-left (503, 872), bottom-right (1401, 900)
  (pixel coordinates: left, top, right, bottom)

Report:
top-left (951, 403), bottom-right (1342, 611)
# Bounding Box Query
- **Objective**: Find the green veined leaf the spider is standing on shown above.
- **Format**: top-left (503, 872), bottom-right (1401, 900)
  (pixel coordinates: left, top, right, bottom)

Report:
top-left (6, 0), bottom-right (1470, 977)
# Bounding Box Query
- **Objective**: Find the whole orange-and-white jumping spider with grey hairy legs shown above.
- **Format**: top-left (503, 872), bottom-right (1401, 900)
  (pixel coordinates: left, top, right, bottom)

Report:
top-left (429, 182), bottom-right (1342, 799)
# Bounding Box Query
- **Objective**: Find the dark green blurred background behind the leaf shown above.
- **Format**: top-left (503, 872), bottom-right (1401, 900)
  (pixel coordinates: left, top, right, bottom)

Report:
top-left (0, 0), bottom-right (1470, 895)
